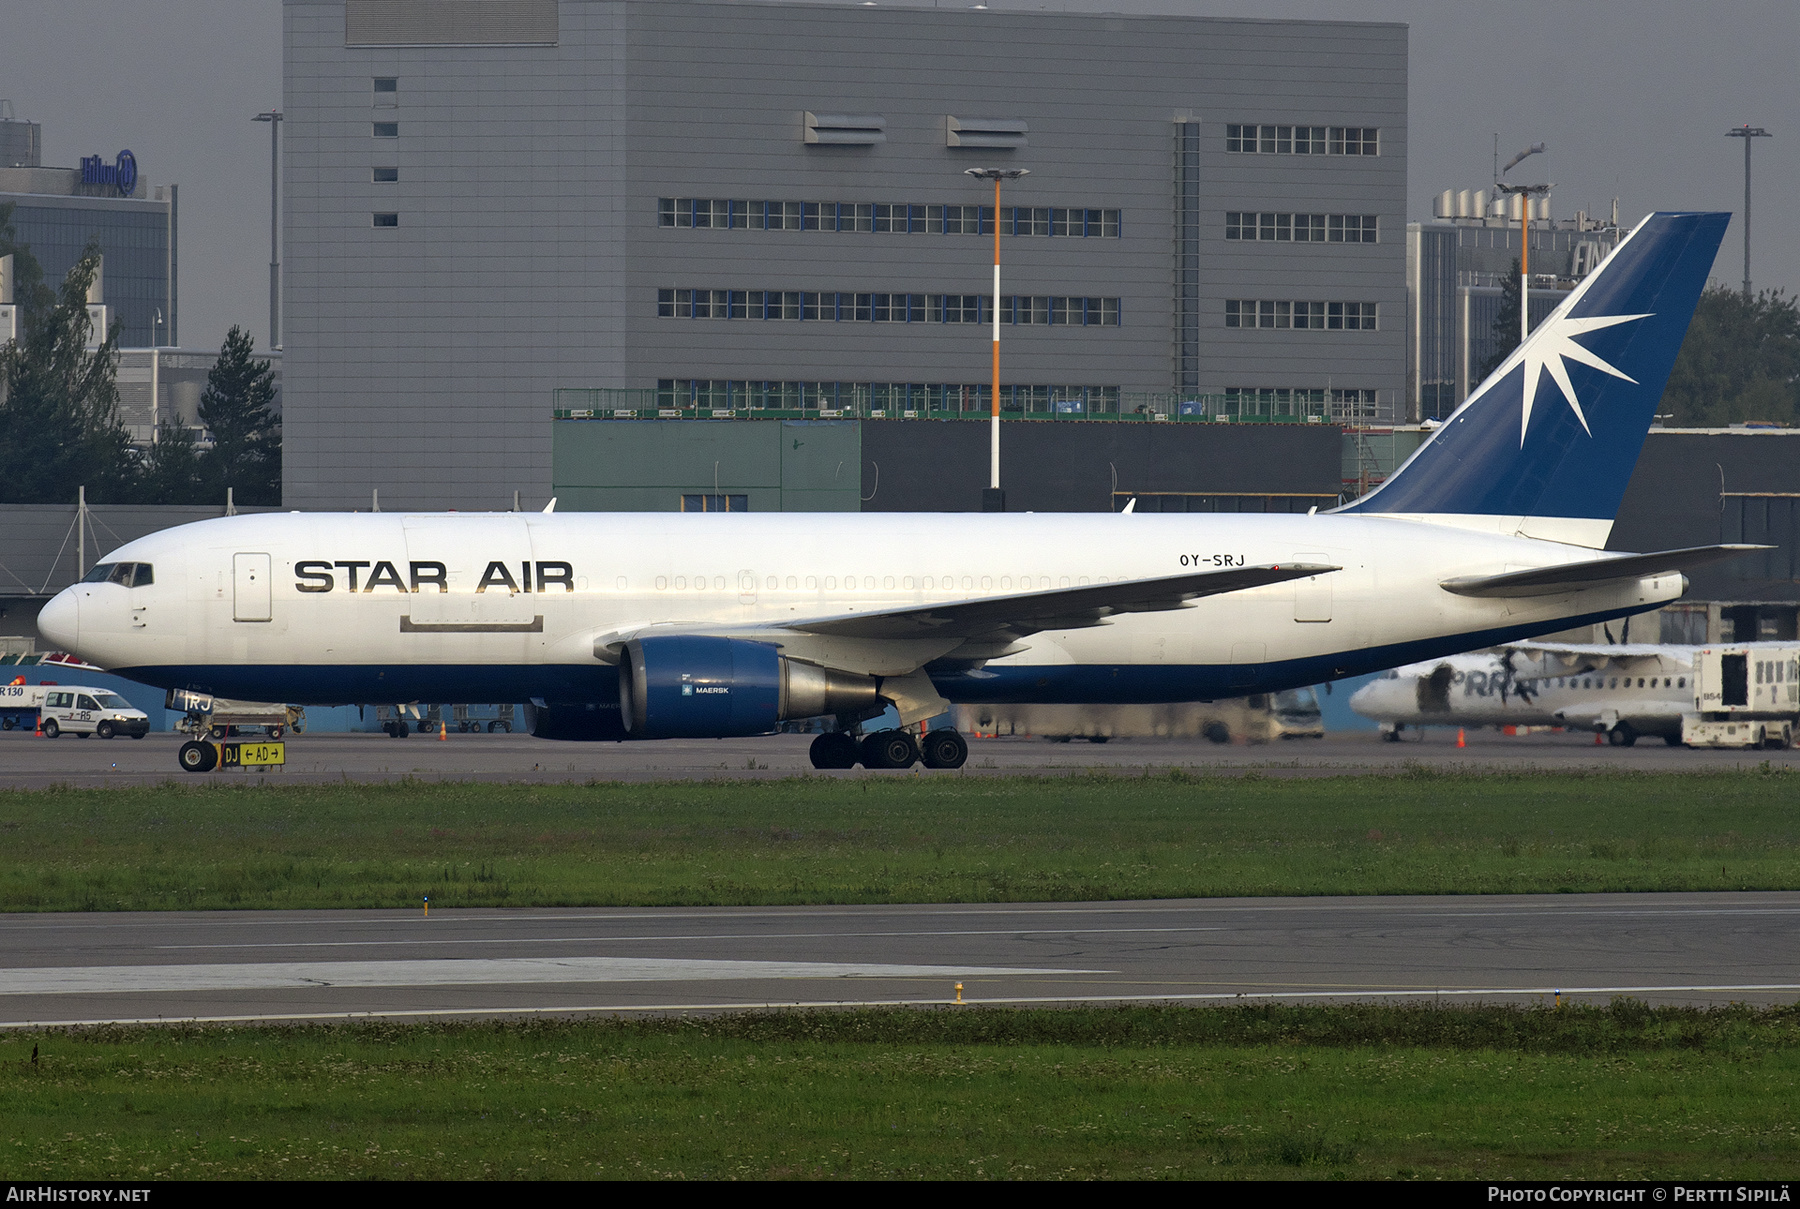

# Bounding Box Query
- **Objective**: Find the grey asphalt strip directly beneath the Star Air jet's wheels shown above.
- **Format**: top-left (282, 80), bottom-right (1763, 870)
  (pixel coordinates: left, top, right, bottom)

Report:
top-left (0, 730), bottom-right (1800, 788)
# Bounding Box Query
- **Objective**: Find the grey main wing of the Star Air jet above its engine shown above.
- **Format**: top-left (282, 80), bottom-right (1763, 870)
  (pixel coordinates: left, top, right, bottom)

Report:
top-left (785, 563), bottom-right (1341, 639)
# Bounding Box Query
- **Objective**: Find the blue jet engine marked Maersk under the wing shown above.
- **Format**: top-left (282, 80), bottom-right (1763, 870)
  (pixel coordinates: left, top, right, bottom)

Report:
top-left (619, 635), bottom-right (882, 739)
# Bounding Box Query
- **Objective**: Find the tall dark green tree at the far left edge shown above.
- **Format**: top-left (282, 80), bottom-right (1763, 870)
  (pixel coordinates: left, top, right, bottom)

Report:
top-left (0, 239), bottom-right (135, 504)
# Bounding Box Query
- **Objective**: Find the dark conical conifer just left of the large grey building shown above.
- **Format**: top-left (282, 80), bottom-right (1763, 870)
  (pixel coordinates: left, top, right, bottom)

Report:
top-left (200, 327), bottom-right (281, 504)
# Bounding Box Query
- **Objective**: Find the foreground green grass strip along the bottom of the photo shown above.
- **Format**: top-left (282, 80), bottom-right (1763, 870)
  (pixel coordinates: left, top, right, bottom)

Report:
top-left (0, 1000), bottom-right (1800, 1180)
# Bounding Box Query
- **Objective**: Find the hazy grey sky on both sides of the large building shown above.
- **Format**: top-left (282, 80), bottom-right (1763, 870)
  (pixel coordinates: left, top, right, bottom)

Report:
top-left (0, 0), bottom-right (1800, 347)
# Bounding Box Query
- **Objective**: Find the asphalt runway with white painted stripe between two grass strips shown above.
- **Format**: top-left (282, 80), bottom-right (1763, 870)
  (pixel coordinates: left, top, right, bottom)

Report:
top-left (0, 892), bottom-right (1800, 1027)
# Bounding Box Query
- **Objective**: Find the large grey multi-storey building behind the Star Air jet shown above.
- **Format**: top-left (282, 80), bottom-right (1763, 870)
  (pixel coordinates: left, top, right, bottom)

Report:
top-left (283, 0), bottom-right (1408, 509)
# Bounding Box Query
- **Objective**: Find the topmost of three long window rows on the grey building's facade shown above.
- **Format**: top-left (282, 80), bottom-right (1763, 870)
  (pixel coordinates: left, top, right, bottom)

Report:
top-left (657, 198), bottom-right (1120, 239)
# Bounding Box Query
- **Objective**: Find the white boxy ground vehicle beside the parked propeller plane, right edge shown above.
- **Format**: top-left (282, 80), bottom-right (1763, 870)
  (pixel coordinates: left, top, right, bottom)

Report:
top-left (1681, 642), bottom-right (1800, 747)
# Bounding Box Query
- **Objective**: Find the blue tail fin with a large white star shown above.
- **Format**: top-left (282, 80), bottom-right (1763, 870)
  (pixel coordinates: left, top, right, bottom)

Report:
top-left (1341, 212), bottom-right (1732, 542)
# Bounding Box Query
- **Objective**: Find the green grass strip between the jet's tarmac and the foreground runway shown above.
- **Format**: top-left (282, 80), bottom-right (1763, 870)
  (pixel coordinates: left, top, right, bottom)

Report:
top-left (0, 768), bottom-right (1800, 910)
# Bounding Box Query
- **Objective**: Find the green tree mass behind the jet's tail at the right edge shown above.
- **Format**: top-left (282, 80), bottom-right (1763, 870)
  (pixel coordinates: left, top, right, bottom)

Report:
top-left (1661, 286), bottom-right (1800, 428)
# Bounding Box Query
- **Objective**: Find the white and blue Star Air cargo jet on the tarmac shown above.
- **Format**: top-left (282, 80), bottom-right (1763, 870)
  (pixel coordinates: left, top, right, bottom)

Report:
top-left (38, 214), bottom-right (1748, 768)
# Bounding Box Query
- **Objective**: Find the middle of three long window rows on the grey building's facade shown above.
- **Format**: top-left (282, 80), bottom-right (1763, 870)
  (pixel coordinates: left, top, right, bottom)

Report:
top-left (657, 290), bottom-right (1120, 327)
